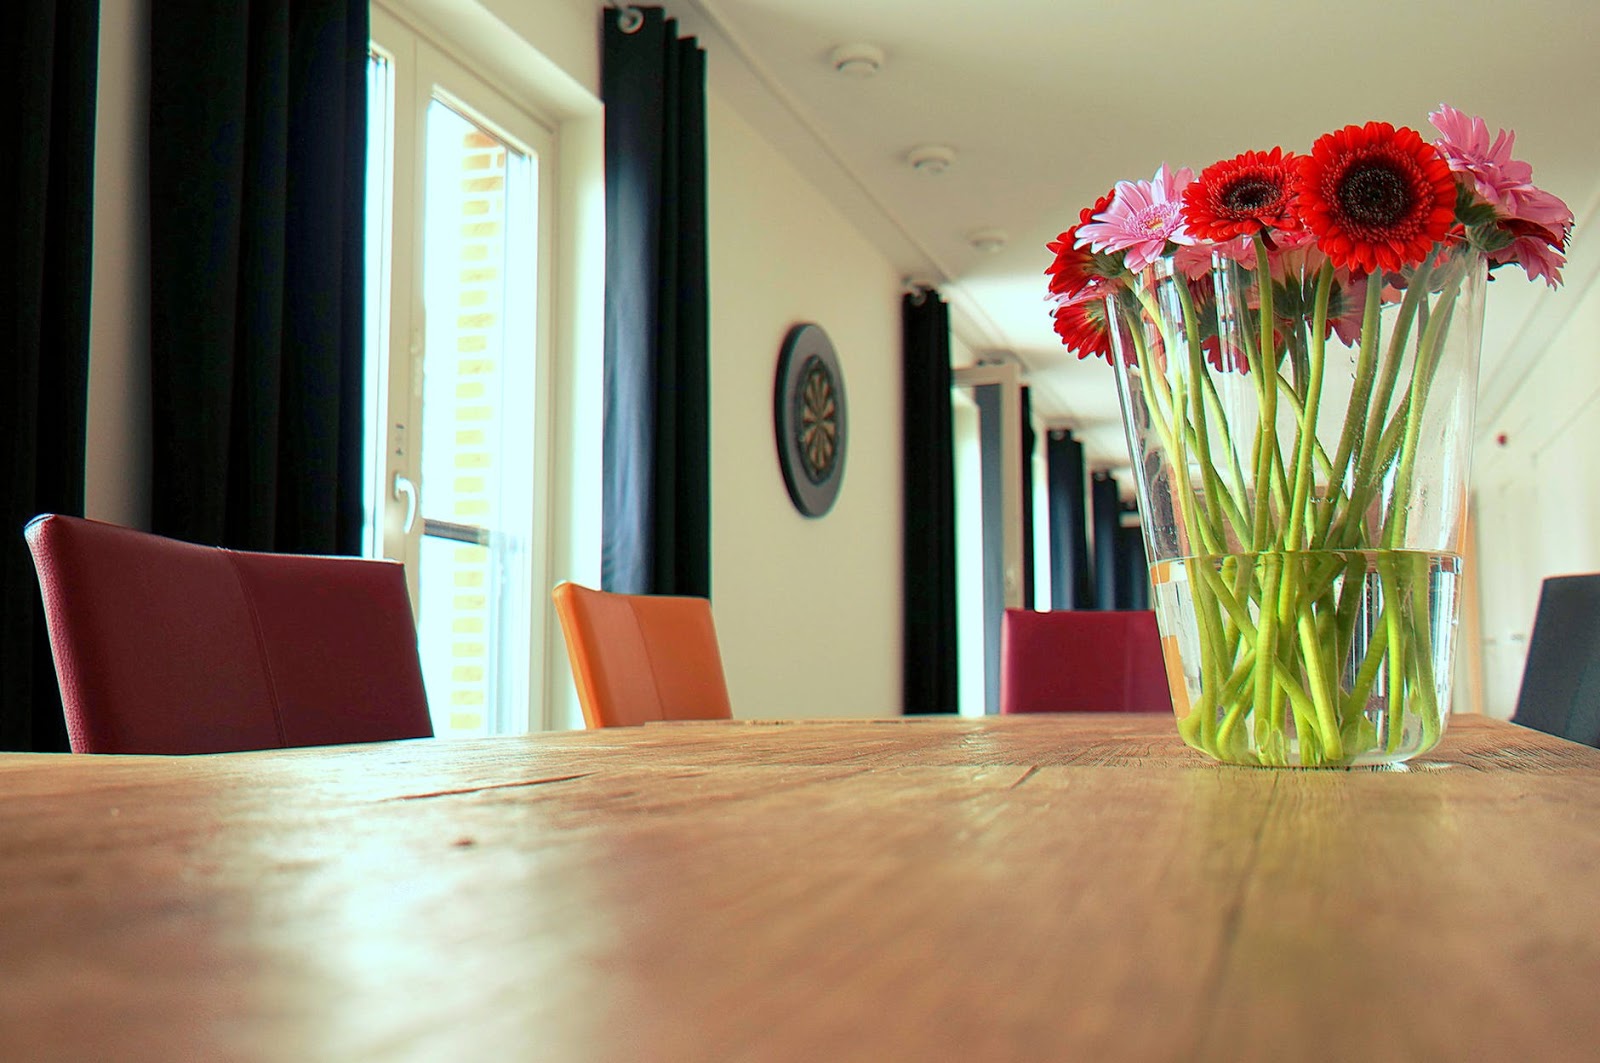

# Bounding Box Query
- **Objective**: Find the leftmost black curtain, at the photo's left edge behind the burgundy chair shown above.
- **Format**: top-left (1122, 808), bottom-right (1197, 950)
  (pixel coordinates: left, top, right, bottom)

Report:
top-left (0, 0), bottom-right (99, 752)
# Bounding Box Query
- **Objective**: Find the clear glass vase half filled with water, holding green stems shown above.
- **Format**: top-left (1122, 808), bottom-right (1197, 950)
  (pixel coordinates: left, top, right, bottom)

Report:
top-left (1107, 242), bottom-right (1486, 767)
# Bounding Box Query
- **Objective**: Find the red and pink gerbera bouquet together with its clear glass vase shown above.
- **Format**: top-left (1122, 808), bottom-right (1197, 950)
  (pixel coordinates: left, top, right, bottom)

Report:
top-left (1046, 107), bottom-right (1573, 767)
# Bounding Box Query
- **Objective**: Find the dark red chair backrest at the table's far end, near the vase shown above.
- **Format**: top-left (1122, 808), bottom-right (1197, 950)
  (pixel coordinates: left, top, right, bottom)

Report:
top-left (1000, 608), bottom-right (1173, 712)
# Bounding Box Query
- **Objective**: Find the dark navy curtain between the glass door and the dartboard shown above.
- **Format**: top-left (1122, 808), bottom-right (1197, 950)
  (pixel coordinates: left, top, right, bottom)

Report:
top-left (600, 8), bottom-right (710, 597)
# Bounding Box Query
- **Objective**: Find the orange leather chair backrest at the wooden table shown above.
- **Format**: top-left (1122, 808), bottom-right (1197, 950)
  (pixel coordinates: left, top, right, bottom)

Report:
top-left (550, 583), bottom-right (733, 727)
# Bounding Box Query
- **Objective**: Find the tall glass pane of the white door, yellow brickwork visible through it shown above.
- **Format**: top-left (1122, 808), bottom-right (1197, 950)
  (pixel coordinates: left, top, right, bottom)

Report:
top-left (414, 98), bottom-right (538, 735)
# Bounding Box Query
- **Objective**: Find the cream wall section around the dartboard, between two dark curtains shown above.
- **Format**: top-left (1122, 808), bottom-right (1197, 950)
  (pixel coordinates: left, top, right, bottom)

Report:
top-left (707, 89), bottom-right (901, 717)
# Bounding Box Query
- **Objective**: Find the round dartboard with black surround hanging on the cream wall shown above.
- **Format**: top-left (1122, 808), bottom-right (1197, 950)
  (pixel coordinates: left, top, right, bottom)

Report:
top-left (773, 323), bottom-right (848, 517)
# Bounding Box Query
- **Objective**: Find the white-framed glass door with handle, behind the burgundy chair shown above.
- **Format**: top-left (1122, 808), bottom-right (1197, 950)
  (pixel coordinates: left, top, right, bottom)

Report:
top-left (368, 11), bottom-right (549, 736)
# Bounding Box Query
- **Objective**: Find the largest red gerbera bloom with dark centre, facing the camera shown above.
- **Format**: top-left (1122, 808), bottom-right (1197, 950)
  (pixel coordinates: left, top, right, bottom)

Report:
top-left (1296, 122), bottom-right (1456, 274)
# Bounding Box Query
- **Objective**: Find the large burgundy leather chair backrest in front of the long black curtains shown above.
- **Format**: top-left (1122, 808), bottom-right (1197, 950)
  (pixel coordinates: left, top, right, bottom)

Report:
top-left (26, 515), bottom-right (434, 754)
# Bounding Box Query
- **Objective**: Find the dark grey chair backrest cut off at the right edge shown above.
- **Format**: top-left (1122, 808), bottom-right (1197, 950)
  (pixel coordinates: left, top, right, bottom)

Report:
top-left (1510, 573), bottom-right (1600, 746)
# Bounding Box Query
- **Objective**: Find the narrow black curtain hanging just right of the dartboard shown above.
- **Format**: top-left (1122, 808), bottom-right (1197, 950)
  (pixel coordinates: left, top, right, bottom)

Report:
top-left (901, 291), bottom-right (957, 716)
